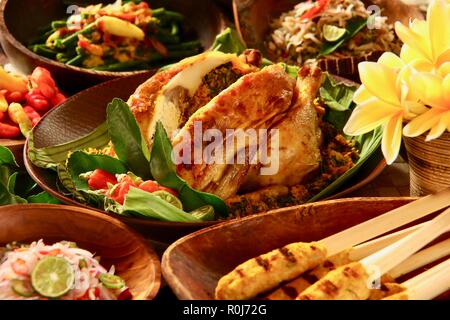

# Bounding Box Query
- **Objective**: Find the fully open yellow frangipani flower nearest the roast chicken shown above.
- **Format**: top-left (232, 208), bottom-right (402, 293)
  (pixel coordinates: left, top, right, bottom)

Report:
top-left (344, 53), bottom-right (427, 164)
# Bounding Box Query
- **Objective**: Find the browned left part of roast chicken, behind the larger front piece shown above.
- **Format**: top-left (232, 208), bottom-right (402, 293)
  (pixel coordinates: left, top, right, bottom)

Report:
top-left (128, 50), bottom-right (260, 146)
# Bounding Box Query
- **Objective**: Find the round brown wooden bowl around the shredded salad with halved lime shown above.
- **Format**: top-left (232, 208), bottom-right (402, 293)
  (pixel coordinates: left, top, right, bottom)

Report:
top-left (0, 205), bottom-right (161, 300)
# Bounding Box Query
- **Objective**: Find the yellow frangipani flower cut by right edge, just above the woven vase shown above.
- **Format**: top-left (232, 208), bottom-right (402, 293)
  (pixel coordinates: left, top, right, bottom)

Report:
top-left (403, 70), bottom-right (450, 141)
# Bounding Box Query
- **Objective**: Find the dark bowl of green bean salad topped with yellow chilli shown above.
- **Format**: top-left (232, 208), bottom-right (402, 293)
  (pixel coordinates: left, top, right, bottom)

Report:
top-left (0, 0), bottom-right (226, 92)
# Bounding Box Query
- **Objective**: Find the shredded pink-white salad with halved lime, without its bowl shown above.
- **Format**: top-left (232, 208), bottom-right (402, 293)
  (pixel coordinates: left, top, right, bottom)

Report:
top-left (0, 240), bottom-right (131, 300)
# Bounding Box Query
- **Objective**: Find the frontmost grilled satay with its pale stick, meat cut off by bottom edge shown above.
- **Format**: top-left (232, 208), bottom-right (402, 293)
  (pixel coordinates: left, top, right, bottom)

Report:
top-left (297, 209), bottom-right (450, 300)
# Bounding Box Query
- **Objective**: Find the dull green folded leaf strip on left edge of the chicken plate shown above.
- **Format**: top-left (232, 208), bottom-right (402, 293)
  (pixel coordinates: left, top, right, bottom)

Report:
top-left (28, 122), bottom-right (110, 170)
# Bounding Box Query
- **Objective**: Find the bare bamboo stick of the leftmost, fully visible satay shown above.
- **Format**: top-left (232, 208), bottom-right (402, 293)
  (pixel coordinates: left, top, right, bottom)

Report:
top-left (319, 188), bottom-right (450, 256)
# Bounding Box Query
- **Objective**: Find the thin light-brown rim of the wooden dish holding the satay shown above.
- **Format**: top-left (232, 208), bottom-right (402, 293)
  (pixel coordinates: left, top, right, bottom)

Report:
top-left (161, 197), bottom-right (418, 300)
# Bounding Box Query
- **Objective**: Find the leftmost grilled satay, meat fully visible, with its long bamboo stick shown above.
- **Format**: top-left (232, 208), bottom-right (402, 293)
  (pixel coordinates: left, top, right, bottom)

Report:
top-left (215, 188), bottom-right (450, 300)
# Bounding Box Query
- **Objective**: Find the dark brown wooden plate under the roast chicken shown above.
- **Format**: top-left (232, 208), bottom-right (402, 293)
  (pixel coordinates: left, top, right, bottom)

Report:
top-left (24, 73), bottom-right (386, 243)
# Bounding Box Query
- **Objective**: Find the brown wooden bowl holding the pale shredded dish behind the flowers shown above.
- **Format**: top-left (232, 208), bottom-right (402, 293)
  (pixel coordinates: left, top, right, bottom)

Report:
top-left (233, 0), bottom-right (423, 81)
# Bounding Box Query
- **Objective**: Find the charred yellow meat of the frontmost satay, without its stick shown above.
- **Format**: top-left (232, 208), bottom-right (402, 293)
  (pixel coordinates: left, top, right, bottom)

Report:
top-left (297, 262), bottom-right (371, 300)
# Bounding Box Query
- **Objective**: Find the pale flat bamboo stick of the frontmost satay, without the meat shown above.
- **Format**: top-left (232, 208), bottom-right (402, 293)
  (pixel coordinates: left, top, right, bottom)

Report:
top-left (361, 209), bottom-right (450, 274)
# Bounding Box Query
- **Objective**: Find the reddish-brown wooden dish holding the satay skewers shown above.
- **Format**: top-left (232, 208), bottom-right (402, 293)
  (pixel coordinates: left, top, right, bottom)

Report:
top-left (162, 198), bottom-right (450, 300)
